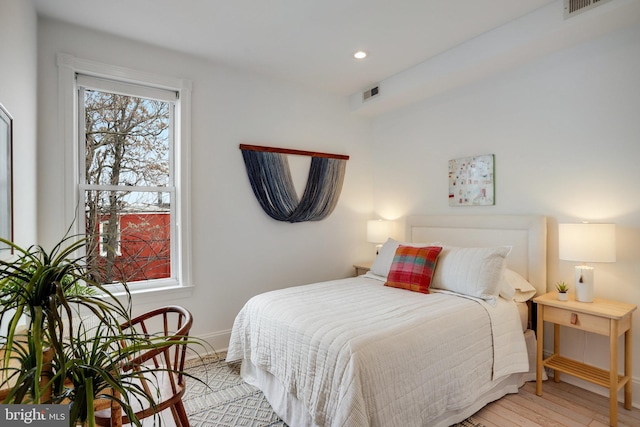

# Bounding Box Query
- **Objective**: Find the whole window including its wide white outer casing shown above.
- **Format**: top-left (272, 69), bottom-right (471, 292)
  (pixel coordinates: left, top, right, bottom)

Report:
top-left (58, 54), bottom-right (191, 293)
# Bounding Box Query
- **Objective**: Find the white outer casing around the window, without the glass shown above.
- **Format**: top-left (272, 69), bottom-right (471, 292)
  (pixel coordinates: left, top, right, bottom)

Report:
top-left (57, 54), bottom-right (192, 297)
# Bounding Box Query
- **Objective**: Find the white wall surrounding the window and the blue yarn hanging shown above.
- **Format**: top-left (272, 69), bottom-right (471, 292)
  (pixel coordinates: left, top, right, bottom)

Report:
top-left (38, 19), bottom-right (373, 349)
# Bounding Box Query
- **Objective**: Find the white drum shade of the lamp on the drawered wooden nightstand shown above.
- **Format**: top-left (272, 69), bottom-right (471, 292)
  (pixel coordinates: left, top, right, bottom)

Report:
top-left (558, 223), bottom-right (616, 262)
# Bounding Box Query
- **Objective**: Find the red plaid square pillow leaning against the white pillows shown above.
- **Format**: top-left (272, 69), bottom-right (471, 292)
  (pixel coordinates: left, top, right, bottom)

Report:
top-left (384, 245), bottom-right (442, 294)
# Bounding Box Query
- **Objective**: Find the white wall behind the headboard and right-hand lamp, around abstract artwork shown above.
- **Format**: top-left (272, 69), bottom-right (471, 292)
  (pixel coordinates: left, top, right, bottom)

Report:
top-left (373, 20), bottom-right (640, 405)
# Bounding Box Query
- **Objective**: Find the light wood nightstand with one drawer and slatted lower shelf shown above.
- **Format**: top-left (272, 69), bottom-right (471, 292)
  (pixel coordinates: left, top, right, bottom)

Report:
top-left (534, 292), bottom-right (637, 426)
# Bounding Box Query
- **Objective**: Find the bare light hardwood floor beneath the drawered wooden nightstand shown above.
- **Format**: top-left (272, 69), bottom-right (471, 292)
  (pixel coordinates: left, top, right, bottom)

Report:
top-left (473, 380), bottom-right (640, 427)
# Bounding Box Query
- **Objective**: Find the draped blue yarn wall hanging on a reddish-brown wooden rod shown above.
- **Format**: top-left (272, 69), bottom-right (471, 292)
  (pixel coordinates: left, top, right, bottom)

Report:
top-left (240, 144), bottom-right (349, 222)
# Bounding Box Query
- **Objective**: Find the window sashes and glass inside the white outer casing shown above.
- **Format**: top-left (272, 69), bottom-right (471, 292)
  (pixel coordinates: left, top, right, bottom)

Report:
top-left (77, 75), bottom-right (177, 286)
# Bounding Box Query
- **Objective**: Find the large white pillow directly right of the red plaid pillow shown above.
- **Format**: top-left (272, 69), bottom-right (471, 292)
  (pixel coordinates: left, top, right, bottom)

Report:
top-left (431, 246), bottom-right (511, 302)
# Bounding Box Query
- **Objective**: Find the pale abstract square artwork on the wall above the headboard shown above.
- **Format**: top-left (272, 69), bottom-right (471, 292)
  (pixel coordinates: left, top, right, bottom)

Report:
top-left (449, 154), bottom-right (496, 206)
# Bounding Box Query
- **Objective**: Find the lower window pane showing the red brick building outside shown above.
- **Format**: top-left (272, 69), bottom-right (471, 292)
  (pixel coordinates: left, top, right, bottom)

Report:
top-left (85, 190), bottom-right (171, 283)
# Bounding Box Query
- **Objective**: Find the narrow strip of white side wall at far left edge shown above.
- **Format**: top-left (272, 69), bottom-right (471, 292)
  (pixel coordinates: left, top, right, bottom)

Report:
top-left (0, 0), bottom-right (38, 247)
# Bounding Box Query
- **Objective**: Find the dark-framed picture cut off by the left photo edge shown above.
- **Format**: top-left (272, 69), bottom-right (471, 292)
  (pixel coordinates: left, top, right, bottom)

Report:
top-left (0, 104), bottom-right (13, 252)
